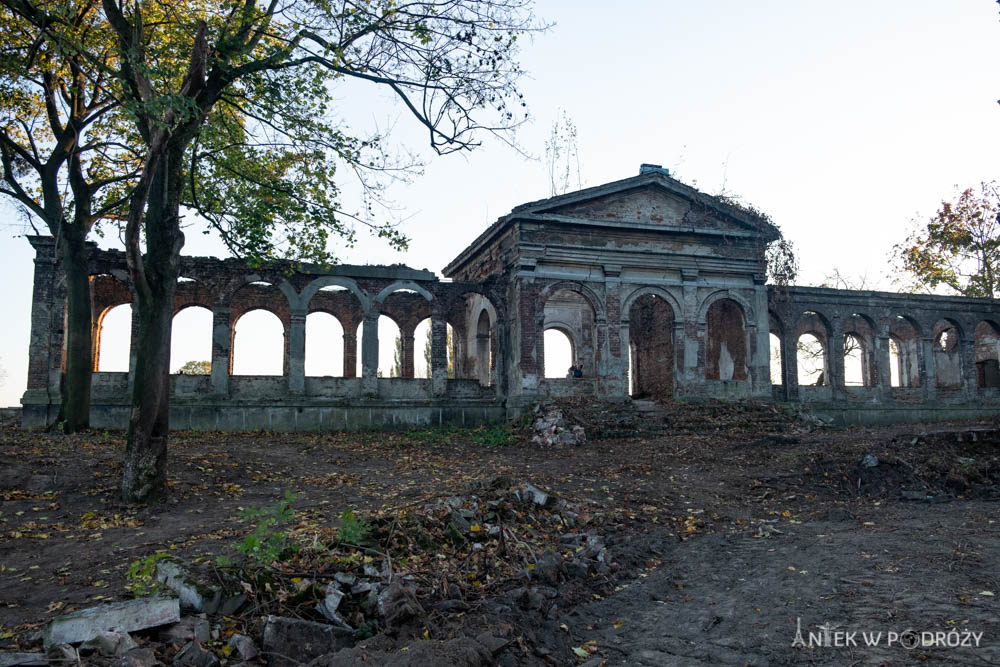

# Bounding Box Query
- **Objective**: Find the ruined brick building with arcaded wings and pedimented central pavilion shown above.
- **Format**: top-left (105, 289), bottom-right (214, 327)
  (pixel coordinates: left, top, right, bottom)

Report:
top-left (22, 165), bottom-right (1000, 430)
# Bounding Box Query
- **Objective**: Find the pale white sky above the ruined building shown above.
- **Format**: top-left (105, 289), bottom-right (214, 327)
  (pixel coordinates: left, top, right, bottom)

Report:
top-left (0, 0), bottom-right (1000, 405)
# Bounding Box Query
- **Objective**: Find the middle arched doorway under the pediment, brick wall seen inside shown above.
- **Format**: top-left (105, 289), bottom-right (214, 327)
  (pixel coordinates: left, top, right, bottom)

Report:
top-left (628, 294), bottom-right (674, 397)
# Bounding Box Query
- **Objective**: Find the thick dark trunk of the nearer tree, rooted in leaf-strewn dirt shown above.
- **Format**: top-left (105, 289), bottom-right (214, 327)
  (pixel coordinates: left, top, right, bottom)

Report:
top-left (122, 142), bottom-right (185, 503)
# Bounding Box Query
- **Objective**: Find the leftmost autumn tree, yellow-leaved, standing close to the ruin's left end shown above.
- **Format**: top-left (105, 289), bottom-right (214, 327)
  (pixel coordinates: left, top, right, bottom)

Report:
top-left (0, 0), bottom-right (141, 432)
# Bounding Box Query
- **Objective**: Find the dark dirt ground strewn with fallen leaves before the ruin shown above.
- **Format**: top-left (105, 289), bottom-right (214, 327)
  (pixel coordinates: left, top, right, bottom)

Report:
top-left (0, 403), bottom-right (1000, 666)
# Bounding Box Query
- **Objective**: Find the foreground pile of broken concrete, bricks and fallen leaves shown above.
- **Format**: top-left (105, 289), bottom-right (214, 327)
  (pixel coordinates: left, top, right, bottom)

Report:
top-left (0, 477), bottom-right (619, 667)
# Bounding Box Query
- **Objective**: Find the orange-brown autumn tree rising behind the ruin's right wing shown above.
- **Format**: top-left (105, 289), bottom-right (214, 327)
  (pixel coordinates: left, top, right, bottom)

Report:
top-left (893, 182), bottom-right (1000, 299)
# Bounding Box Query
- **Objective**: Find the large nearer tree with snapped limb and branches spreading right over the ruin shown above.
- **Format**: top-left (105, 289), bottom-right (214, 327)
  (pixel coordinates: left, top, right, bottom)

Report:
top-left (0, 0), bottom-right (534, 502)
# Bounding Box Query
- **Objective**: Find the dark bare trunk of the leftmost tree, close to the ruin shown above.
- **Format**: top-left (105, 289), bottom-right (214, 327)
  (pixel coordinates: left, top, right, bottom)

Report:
top-left (59, 232), bottom-right (94, 433)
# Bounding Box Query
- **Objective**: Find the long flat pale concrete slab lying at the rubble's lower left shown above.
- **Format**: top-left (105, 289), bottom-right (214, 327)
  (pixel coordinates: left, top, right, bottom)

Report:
top-left (42, 598), bottom-right (181, 648)
